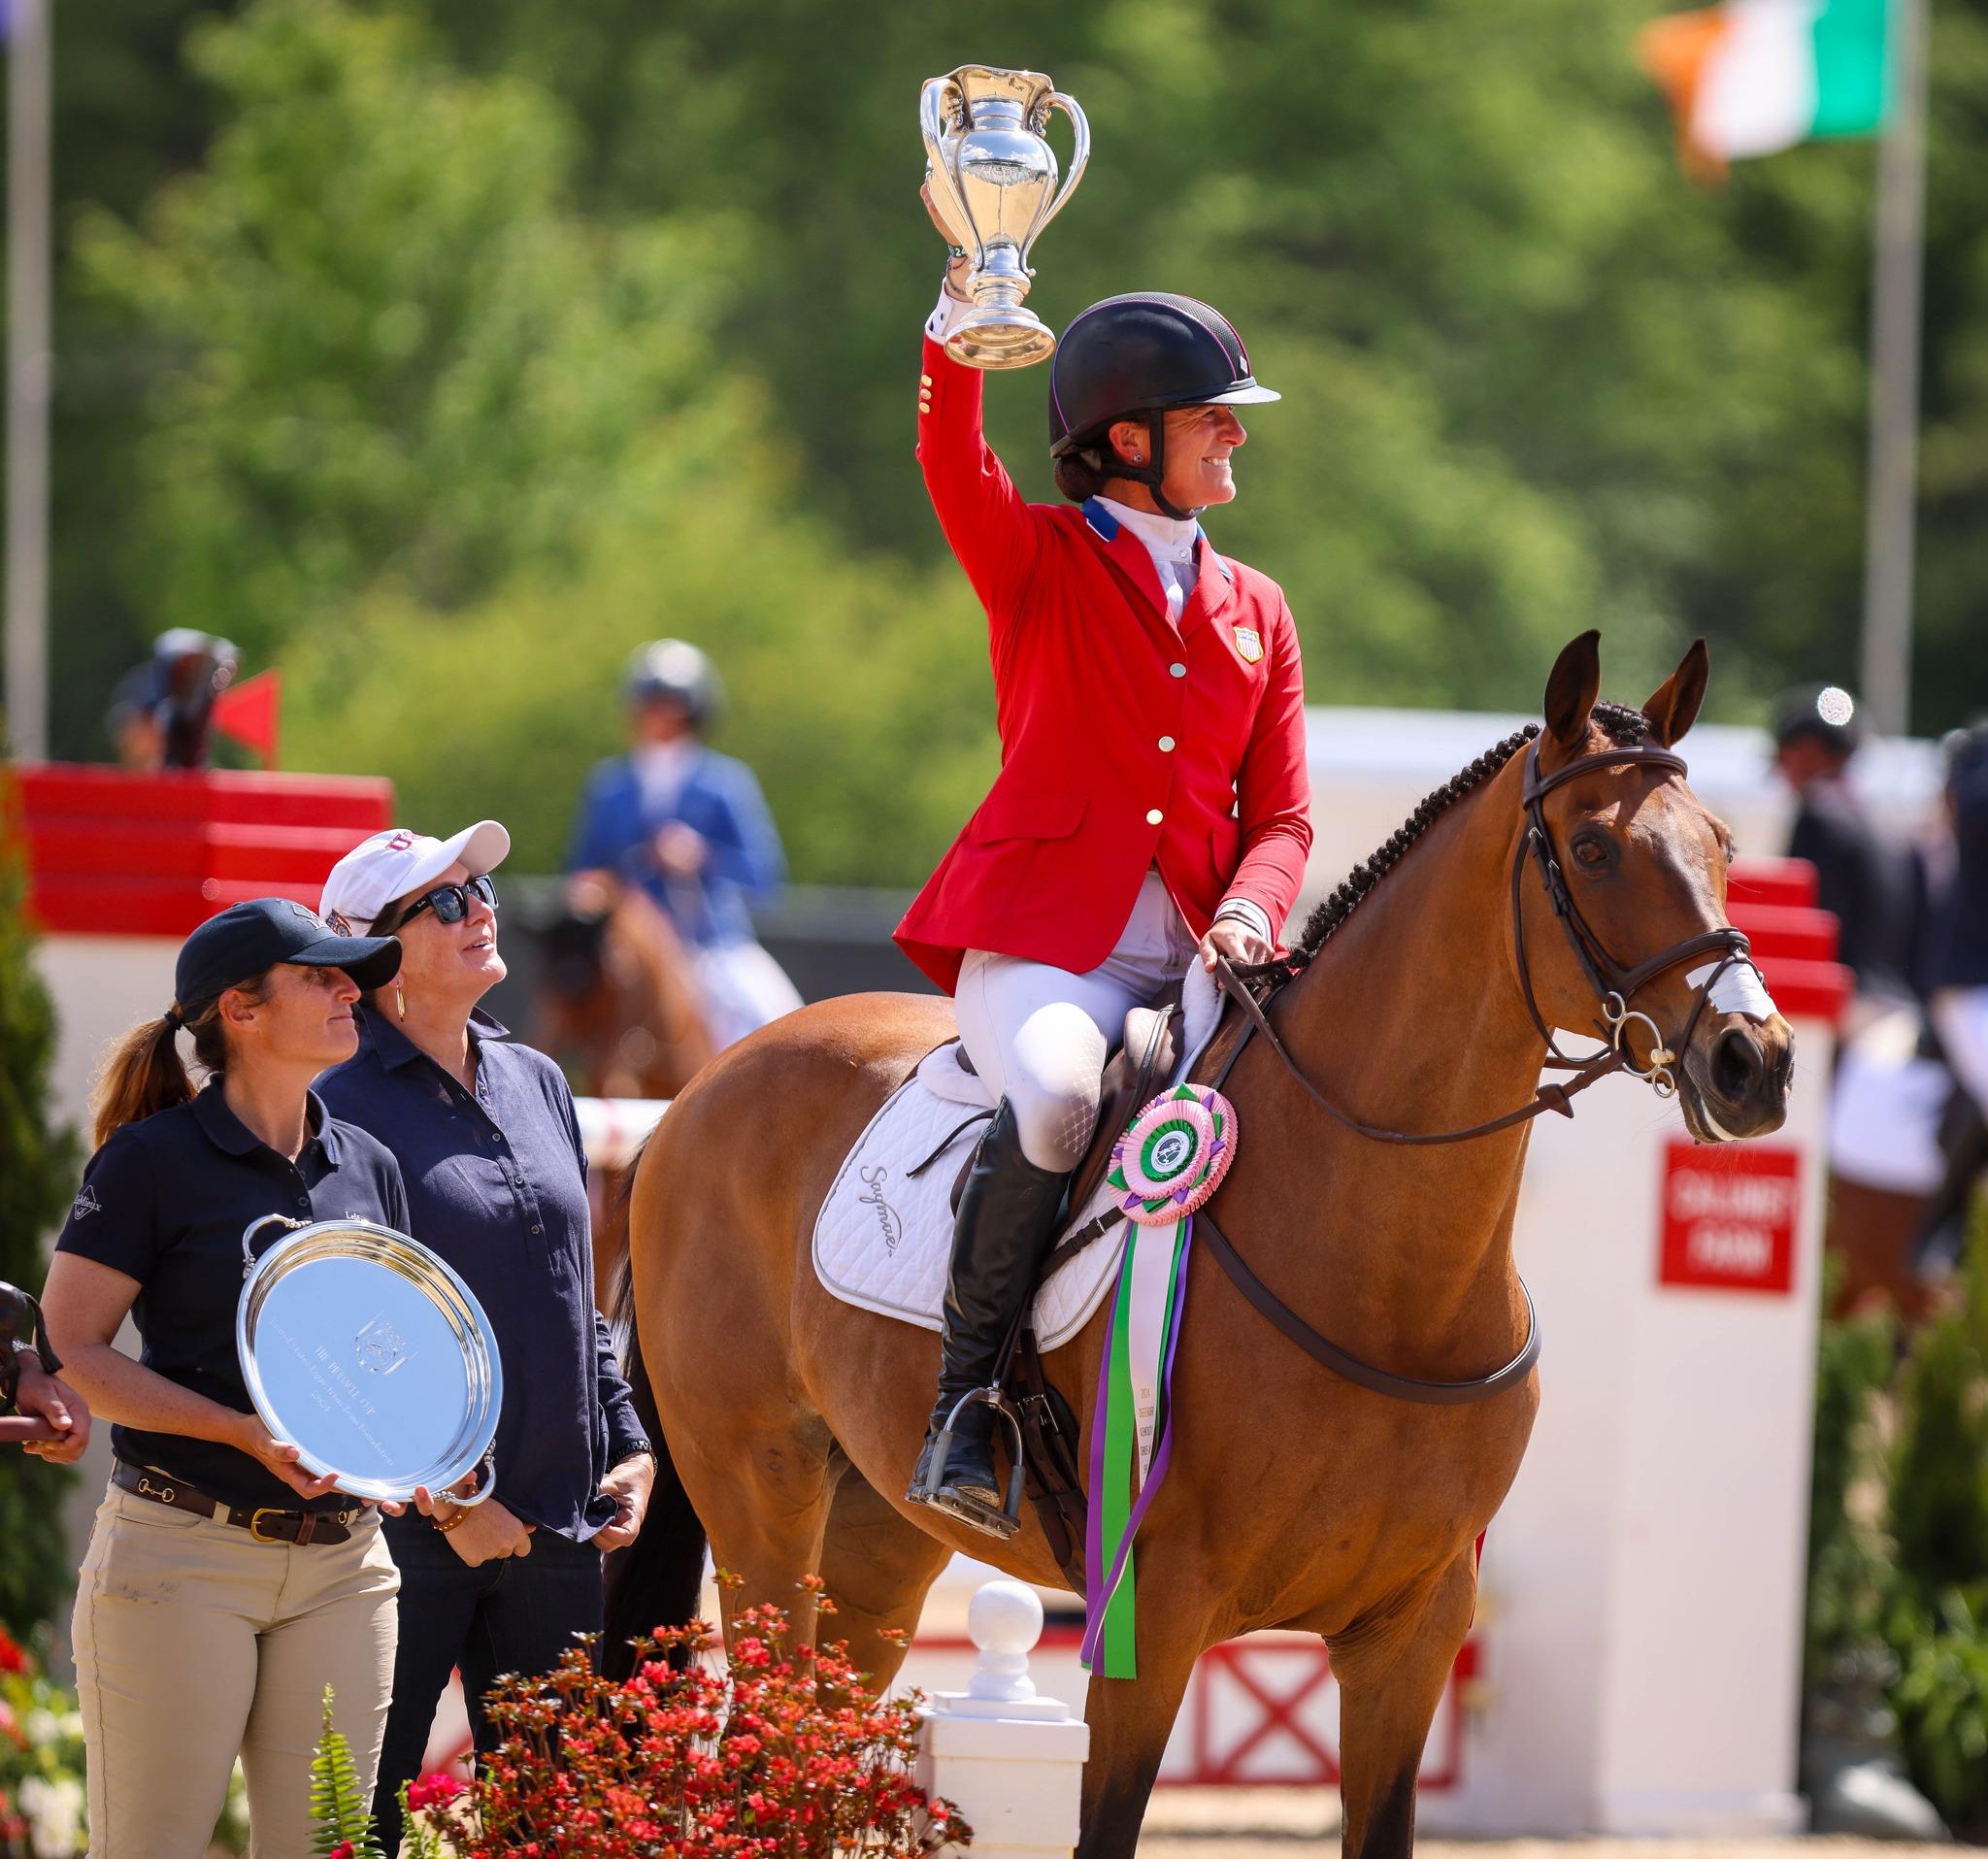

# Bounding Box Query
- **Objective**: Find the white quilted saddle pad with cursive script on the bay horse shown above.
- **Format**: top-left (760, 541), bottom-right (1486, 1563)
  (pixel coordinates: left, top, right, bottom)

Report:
top-left (813, 968), bottom-right (1220, 1350)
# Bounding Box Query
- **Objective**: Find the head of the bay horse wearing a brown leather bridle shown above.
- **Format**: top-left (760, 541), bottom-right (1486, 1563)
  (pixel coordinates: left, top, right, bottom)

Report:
top-left (1519, 632), bottom-right (1795, 1144)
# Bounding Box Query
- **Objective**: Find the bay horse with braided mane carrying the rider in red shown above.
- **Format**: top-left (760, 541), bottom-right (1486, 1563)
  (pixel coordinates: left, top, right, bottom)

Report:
top-left (609, 632), bottom-right (1793, 1859)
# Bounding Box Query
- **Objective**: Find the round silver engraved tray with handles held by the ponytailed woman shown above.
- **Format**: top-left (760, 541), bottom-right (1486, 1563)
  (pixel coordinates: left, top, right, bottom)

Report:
top-left (235, 1216), bottom-right (503, 1501)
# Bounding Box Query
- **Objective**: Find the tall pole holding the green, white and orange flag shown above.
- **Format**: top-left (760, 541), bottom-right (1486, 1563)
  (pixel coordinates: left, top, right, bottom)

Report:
top-left (1863, 0), bottom-right (1929, 736)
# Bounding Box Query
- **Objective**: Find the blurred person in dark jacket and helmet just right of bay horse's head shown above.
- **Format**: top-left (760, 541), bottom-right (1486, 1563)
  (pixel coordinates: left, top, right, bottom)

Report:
top-left (1773, 684), bottom-right (1922, 1002)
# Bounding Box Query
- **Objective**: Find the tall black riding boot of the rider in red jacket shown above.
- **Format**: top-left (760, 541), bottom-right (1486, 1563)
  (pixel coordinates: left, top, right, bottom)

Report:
top-left (905, 1098), bottom-right (1070, 1535)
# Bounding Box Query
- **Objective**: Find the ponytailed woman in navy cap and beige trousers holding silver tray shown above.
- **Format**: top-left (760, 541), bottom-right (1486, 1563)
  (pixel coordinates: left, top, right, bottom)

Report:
top-left (42, 897), bottom-right (408, 1859)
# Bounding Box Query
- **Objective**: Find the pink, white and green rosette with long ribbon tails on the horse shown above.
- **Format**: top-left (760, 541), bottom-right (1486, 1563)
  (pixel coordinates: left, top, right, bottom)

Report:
top-left (1083, 1083), bottom-right (1237, 1678)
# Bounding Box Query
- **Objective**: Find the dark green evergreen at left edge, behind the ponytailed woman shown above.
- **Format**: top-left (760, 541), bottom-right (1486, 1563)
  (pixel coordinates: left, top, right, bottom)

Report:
top-left (0, 779), bottom-right (80, 1635)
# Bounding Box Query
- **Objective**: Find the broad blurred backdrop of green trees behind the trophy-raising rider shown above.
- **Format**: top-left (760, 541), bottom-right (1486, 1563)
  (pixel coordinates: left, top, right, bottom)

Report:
top-left (43, 0), bottom-right (1988, 880)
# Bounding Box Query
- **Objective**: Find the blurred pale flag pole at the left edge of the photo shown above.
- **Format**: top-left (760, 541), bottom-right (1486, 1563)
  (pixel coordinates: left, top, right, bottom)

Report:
top-left (6, 0), bottom-right (53, 761)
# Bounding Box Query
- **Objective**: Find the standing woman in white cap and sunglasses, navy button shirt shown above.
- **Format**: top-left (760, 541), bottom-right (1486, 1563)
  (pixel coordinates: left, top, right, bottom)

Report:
top-left (318, 819), bottom-right (656, 1851)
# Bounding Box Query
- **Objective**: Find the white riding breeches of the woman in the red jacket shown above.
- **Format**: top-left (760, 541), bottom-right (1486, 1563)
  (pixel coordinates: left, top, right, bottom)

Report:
top-left (952, 871), bottom-right (1195, 1173)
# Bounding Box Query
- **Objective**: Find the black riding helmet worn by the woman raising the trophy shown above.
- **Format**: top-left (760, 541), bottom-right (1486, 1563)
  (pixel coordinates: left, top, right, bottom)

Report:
top-left (1049, 290), bottom-right (1284, 521)
